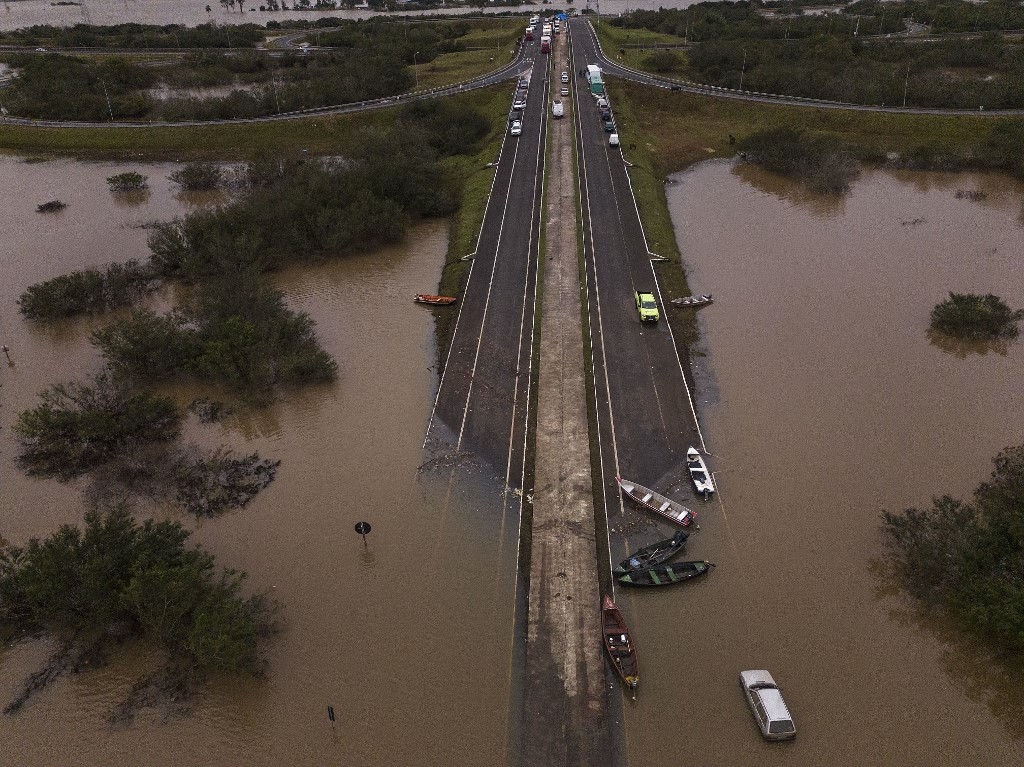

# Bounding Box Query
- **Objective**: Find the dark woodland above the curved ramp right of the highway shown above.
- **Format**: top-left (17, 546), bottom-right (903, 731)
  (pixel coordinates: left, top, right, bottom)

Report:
top-left (610, 1), bottom-right (1024, 110)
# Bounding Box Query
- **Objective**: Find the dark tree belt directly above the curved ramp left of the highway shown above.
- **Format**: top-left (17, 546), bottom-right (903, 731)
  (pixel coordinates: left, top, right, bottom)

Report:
top-left (4, 19), bottom-right (497, 122)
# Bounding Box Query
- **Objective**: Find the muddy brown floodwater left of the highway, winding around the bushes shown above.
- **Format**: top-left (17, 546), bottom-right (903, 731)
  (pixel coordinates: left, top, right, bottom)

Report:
top-left (0, 158), bottom-right (517, 767)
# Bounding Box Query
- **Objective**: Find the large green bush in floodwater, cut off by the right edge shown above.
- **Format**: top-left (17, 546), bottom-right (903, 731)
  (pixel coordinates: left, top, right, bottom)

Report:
top-left (883, 448), bottom-right (1024, 654)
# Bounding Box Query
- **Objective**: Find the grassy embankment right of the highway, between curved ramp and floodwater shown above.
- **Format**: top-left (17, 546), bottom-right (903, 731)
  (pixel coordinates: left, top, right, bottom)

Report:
top-left (605, 74), bottom-right (1015, 345)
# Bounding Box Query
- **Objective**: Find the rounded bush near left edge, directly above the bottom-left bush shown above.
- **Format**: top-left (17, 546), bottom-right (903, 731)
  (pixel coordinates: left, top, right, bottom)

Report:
top-left (14, 373), bottom-right (181, 479)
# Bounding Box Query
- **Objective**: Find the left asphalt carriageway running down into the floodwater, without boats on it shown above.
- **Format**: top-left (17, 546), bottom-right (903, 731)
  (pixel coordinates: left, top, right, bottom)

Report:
top-left (425, 38), bottom-right (549, 489)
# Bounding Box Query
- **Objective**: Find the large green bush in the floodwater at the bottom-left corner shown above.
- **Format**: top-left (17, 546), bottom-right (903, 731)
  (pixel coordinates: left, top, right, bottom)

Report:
top-left (0, 506), bottom-right (273, 714)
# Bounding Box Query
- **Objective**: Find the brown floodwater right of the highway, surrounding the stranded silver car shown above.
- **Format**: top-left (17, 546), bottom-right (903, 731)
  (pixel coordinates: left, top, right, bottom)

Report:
top-left (620, 162), bottom-right (1024, 766)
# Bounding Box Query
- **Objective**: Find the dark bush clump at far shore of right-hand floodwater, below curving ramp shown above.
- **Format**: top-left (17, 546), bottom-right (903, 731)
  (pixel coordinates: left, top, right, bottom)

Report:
top-left (740, 128), bottom-right (860, 195)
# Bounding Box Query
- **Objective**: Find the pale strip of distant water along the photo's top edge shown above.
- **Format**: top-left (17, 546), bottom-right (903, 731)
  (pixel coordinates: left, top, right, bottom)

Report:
top-left (0, 0), bottom-right (696, 30)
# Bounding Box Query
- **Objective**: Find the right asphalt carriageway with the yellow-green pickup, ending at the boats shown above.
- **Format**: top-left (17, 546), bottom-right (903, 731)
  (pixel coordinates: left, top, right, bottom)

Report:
top-left (569, 18), bottom-right (702, 554)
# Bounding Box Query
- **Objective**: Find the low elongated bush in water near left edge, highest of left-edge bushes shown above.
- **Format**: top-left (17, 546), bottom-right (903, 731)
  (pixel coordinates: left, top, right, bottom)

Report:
top-left (17, 260), bottom-right (155, 319)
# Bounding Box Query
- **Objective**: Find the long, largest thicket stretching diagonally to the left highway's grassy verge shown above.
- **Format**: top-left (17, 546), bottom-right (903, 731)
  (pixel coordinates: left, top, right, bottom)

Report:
top-left (150, 113), bottom-right (479, 282)
